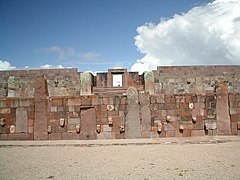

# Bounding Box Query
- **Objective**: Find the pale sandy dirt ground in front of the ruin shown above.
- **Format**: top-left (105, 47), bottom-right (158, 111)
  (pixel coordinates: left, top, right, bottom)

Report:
top-left (0, 141), bottom-right (240, 180)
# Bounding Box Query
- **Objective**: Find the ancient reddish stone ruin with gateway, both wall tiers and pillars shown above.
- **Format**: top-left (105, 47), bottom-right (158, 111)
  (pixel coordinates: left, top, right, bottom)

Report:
top-left (0, 66), bottom-right (240, 140)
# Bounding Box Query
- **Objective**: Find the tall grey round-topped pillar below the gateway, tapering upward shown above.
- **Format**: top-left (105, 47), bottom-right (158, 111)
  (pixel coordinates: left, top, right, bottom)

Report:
top-left (125, 86), bottom-right (141, 139)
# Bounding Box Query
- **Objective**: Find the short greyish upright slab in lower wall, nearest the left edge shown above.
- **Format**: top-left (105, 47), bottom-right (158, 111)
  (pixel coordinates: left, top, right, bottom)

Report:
top-left (16, 107), bottom-right (28, 133)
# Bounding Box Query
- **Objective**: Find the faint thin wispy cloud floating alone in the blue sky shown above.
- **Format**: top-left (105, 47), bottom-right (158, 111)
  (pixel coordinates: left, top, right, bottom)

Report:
top-left (34, 46), bottom-right (100, 60)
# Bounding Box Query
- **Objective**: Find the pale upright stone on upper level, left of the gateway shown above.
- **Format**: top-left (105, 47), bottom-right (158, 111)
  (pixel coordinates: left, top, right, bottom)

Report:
top-left (80, 72), bottom-right (93, 95)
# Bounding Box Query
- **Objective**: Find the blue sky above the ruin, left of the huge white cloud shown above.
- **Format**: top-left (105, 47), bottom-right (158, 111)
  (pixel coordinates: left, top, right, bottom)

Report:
top-left (0, 0), bottom-right (239, 72)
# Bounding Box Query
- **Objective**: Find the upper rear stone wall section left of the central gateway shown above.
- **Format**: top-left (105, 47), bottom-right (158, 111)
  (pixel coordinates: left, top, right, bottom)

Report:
top-left (0, 68), bottom-right (80, 97)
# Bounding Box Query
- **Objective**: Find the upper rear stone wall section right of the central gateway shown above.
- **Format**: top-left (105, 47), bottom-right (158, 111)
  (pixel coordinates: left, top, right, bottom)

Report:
top-left (153, 66), bottom-right (240, 94)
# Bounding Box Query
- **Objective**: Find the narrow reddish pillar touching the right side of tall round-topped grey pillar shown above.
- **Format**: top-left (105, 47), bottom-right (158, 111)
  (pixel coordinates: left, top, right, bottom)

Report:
top-left (139, 93), bottom-right (151, 132)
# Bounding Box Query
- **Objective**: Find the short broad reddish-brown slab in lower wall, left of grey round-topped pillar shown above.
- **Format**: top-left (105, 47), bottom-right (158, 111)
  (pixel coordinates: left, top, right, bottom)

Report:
top-left (80, 107), bottom-right (97, 140)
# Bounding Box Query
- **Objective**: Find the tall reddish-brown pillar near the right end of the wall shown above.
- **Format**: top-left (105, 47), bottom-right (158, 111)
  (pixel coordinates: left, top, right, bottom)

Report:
top-left (216, 82), bottom-right (231, 135)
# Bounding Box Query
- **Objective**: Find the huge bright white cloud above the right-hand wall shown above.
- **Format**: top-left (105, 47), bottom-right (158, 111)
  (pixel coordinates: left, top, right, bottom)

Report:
top-left (131, 0), bottom-right (240, 72)
